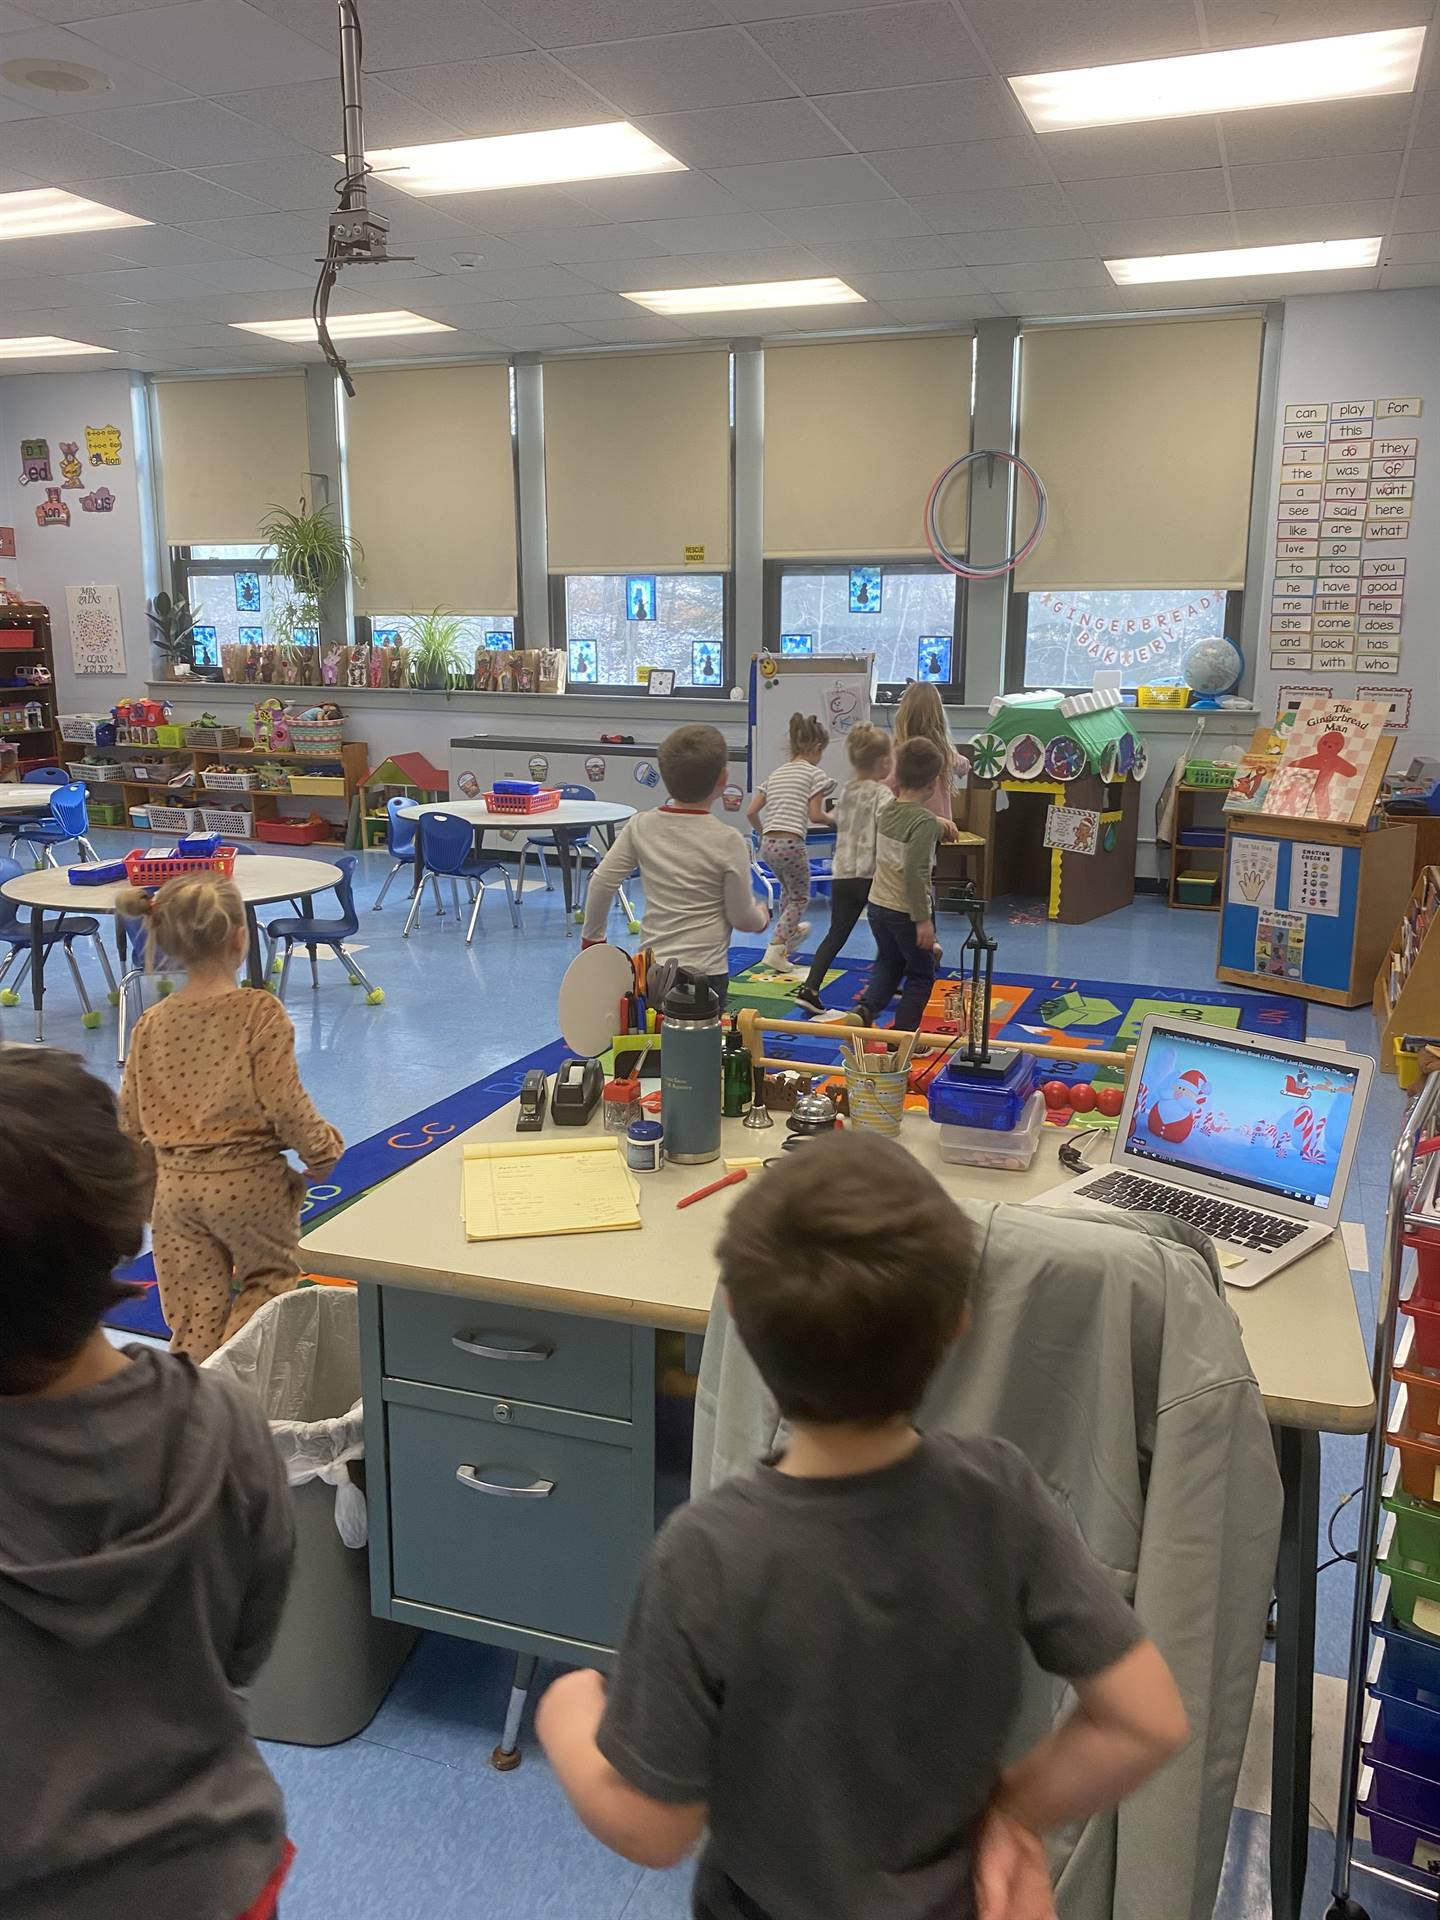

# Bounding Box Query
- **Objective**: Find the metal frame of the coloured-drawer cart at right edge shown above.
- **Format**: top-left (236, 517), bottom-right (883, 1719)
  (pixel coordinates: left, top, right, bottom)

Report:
top-left (1328, 1073), bottom-right (1440, 1920)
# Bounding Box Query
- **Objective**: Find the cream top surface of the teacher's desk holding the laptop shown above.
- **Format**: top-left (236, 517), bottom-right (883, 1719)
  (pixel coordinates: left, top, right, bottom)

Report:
top-left (305, 1102), bottom-right (1375, 1432)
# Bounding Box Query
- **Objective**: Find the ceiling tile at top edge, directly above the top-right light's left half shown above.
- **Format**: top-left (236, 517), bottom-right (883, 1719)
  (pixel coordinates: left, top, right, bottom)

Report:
top-left (964, 0), bottom-right (1202, 73)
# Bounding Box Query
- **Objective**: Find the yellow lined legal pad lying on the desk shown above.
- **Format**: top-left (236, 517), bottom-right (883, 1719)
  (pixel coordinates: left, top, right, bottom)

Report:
top-left (461, 1139), bottom-right (639, 1240)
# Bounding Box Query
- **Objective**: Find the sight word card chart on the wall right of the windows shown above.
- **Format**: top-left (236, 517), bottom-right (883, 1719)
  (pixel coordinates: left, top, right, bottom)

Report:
top-left (1269, 396), bottom-right (1421, 676)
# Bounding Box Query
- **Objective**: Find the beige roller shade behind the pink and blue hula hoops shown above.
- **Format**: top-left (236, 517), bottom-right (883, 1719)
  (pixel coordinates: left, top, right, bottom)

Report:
top-left (1016, 315), bottom-right (1261, 588)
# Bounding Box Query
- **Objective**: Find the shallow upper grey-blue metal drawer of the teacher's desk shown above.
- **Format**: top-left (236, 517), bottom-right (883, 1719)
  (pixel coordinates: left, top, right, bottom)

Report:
top-left (382, 1286), bottom-right (632, 1419)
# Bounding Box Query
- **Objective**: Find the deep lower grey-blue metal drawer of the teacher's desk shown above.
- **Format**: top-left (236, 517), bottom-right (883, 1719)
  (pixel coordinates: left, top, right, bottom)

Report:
top-left (386, 1400), bottom-right (647, 1647)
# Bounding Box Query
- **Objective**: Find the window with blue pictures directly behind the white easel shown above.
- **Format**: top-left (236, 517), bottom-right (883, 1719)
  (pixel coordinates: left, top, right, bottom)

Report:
top-left (768, 561), bottom-right (964, 699)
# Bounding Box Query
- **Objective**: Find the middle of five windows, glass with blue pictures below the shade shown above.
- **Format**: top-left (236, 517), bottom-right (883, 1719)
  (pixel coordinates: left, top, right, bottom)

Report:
top-left (553, 572), bottom-right (732, 697)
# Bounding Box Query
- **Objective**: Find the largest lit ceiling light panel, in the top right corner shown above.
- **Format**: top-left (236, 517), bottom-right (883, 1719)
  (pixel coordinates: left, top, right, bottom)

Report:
top-left (1010, 27), bottom-right (1425, 132)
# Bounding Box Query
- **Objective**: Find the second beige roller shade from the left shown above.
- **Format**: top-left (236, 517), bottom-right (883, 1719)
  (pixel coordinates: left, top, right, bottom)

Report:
top-left (346, 365), bottom-right (515, 612)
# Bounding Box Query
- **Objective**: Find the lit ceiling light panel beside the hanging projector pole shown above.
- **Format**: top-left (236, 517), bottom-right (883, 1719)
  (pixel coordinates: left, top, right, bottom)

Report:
top-left (355, 121), bottom-right (687, 194)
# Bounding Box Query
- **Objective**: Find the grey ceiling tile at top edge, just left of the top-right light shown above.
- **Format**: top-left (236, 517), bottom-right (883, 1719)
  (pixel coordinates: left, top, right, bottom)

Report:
top-left (751, 0), bottom-right (985, 94)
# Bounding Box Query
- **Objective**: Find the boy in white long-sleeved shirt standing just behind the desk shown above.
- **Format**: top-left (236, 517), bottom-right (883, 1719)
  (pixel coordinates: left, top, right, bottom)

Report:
top-left (582, 726), bottom-right (770, 1008)
